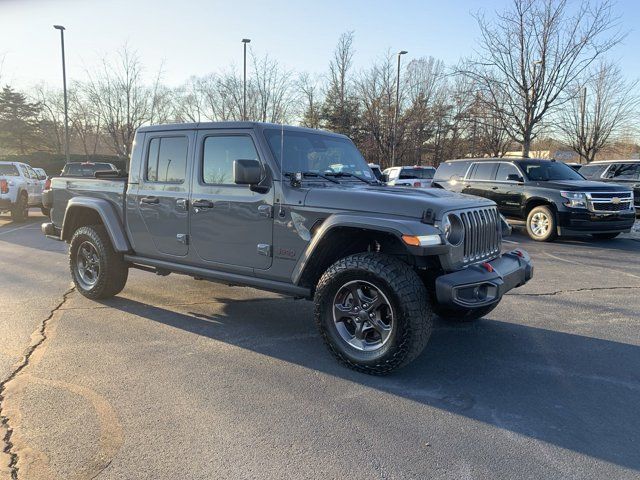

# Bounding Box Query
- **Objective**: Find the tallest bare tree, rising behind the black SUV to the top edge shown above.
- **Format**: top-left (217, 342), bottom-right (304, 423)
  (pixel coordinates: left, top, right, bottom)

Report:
top-left (462, 0), bottom-right (624, 157)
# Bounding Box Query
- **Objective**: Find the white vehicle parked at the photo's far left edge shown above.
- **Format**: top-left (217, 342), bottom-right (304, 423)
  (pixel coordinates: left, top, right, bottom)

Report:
top-left (0, 162), bottom-right (44, 222)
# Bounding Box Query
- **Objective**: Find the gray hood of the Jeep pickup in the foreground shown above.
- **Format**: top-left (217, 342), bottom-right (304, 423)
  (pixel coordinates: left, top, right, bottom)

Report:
top-left (305, 184), bottom-right (495, 218)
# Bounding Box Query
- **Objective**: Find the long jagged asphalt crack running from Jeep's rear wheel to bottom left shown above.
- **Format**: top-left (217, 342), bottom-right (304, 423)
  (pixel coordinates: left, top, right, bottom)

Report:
top-left (0, 287), bottom-right (75, 480)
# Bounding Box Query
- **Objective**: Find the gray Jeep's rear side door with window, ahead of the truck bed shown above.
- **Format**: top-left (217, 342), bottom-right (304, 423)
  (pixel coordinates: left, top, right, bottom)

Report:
top-left (134, 131), bottom-right (194, 257)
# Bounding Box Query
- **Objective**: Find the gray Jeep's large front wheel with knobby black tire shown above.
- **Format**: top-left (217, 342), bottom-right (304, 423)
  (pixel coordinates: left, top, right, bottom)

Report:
top-left (314, 253), bottom-right (433, 375)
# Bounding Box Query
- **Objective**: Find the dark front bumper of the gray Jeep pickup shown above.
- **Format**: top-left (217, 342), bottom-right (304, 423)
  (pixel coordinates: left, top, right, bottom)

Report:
top-left (435, 250), bottom-right (533, 309)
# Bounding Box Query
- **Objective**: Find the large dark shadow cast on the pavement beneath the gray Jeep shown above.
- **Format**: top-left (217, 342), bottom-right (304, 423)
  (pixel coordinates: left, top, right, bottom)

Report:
top-left (99, 298), bottom-right (640, 469)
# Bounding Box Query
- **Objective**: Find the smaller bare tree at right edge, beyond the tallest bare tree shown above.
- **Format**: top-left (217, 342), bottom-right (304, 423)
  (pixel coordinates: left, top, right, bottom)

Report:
top-left (558, 62), bottom-right (640, 163)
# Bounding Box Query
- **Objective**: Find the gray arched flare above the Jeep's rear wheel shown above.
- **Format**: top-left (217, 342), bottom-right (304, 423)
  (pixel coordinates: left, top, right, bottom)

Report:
top-left (60, 197), bottom-right (131, 252)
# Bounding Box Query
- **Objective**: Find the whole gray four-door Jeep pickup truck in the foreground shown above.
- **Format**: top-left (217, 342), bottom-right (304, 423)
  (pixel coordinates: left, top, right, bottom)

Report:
top-left (42, 122), bottom-right (533, 374)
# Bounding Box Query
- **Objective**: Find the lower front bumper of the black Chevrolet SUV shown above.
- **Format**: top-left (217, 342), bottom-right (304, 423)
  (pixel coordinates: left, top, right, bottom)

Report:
top-left (558, 210), bottom-right (636, 235)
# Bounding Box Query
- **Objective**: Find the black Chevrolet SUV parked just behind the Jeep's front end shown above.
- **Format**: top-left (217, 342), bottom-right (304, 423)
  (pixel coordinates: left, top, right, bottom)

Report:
top-left (433, 158), bottom-right (635, 241)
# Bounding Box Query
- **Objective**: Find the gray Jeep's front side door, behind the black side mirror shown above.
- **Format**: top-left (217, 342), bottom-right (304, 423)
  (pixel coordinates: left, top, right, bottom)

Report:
top-left (190, 130), bottom-right (274, 269)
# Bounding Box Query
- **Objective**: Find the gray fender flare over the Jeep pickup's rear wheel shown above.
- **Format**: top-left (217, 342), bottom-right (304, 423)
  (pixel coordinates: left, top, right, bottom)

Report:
top-left (60, 197), bottom-right (131, 252)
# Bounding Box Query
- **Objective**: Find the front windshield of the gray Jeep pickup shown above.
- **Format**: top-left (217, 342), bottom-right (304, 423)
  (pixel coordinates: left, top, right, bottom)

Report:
top-left (264, 128), bottom-right (375, 180)
